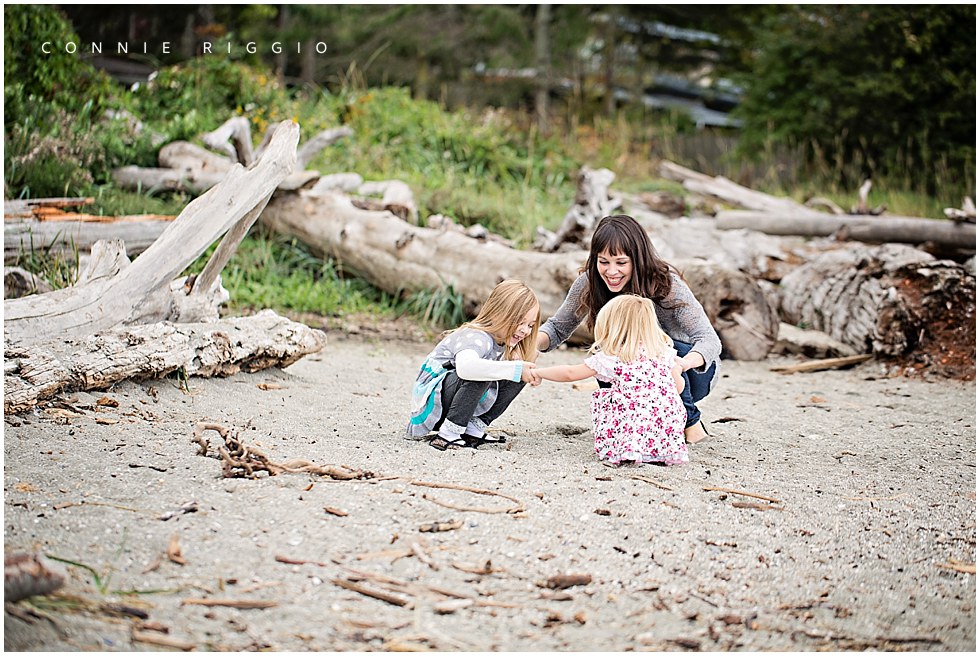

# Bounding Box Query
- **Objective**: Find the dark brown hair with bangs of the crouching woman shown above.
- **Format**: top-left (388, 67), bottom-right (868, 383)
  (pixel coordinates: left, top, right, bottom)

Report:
top-left (579, 214), bottom-right (676, 330)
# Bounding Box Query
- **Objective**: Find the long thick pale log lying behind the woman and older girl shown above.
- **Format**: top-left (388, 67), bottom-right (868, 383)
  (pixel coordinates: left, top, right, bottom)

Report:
top-left (259, 191), bottom-right (778, 359)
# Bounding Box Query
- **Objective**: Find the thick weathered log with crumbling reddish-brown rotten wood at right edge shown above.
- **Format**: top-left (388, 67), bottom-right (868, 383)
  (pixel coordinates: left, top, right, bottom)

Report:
top-left (780, 244), bottom-right (976, 357)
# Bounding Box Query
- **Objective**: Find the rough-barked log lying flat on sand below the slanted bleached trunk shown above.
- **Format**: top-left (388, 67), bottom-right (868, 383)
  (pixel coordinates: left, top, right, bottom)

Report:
top-left (3, 310), bottom-right (326, 413)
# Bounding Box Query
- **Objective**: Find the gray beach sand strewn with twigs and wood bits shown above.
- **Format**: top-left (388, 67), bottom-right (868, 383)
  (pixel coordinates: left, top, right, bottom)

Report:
top-left (4, 333), bottom-right (976, 652)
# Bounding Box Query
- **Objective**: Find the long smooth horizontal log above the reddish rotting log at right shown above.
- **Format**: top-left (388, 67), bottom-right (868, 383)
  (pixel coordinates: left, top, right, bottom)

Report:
top-left (715, 210), bottom-right (977, 249)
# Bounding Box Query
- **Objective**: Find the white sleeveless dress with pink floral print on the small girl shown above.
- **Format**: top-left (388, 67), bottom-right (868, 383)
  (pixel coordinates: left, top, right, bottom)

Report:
top-left (585, 347), bottom-right (688, 465)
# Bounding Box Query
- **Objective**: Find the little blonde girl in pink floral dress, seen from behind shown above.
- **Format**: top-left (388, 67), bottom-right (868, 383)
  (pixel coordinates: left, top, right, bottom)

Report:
top-left (534, 294), bottom-right (688, 466)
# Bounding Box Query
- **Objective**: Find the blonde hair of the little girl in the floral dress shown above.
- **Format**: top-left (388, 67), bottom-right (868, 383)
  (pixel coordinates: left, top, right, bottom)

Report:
top-left (589, 294), bottom-right (673, 362)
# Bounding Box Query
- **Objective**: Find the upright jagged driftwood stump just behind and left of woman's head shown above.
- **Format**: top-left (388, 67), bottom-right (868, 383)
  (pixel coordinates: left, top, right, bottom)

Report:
top-left (534, 167), bottom-right (622, 253)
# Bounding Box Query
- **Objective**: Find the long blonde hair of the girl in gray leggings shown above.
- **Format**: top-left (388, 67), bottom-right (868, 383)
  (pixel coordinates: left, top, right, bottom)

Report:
top-left (456, 280), bottom-right (541, 362)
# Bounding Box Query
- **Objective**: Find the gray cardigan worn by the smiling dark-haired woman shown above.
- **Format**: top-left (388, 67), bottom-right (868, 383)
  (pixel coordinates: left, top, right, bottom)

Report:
top-left (541, 272), bottom-right (721, 389)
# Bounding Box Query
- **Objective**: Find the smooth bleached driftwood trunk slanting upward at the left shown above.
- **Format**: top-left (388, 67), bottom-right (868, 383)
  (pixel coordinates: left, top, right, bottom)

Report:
top-left (4, 122), bottom-right (299, 345)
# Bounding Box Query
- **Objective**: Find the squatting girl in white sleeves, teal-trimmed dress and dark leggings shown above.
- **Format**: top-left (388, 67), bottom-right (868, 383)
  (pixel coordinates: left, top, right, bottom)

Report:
top-left (406, 280), bottom-right (541, 451)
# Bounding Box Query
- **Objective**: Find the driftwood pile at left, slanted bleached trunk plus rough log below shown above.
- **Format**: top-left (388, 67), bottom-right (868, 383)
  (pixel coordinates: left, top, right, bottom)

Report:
top-left (4, 122), bottom-right (325, 413)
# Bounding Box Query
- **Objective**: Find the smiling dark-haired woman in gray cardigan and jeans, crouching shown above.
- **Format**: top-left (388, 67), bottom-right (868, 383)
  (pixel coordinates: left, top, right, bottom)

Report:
top-left (538, 214), bottom-right (721, 444)
